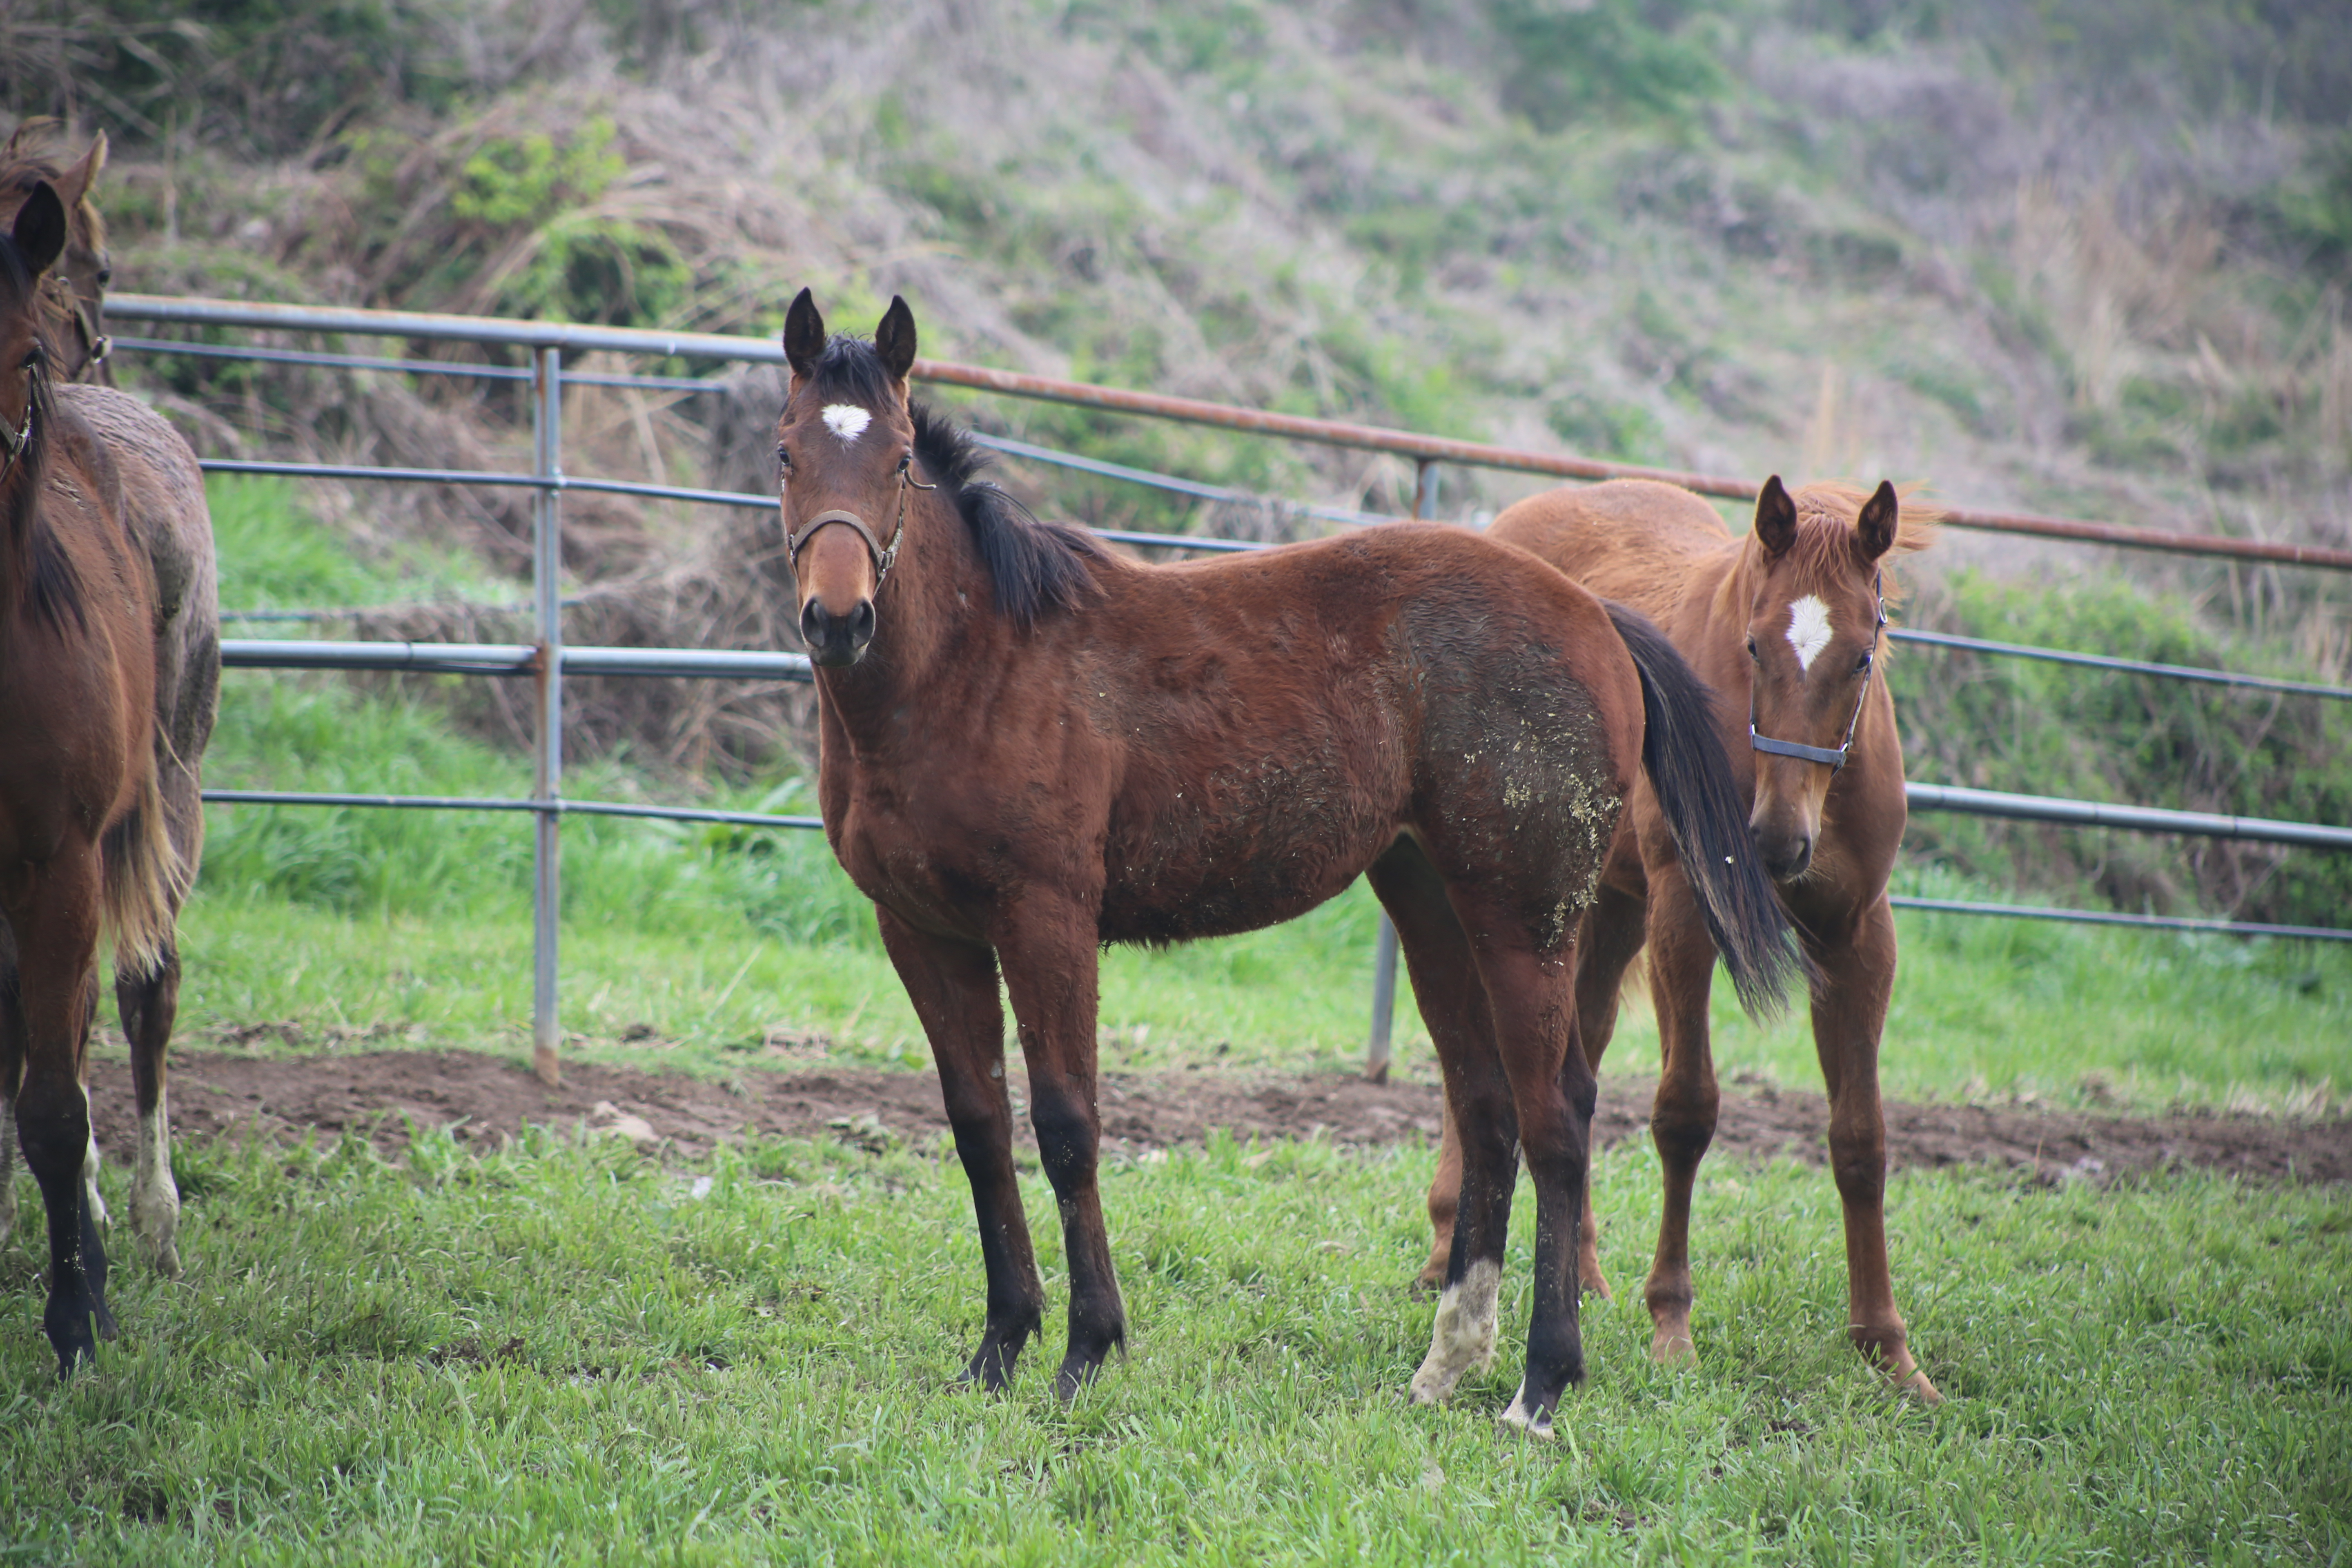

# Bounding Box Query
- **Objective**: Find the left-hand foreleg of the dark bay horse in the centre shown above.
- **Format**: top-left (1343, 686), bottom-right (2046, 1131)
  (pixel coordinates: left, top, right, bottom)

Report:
top-left (877, 910), bottom-right (1044, 1389)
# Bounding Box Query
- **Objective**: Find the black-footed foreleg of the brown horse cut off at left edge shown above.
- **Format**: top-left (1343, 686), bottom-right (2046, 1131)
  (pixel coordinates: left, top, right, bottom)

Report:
top-left (7, 849), bottom-right (115, 1375)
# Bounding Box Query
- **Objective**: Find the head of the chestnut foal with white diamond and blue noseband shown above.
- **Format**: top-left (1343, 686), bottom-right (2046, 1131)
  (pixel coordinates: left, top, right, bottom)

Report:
top-left (1748, 475), bottom-right (1900, 882)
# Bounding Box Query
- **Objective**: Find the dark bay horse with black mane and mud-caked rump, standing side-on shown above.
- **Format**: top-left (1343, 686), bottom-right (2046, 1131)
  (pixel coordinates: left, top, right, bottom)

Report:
top-left (776, 292), bottom-right (1795, 1432)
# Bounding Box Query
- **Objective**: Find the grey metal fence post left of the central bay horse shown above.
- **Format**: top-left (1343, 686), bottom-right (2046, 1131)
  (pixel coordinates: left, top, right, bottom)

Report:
top-left (532, 348), bottom-right (564, 1089)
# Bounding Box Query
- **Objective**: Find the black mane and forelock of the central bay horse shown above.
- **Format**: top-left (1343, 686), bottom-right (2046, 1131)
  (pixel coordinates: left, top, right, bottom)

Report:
top-left (781, 334), bottom-right (1103, 625)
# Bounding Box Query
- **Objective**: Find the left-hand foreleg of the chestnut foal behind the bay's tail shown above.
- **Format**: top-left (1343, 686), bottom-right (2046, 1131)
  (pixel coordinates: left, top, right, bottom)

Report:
top-left (1644, 872), bottom-right (1719, 1363)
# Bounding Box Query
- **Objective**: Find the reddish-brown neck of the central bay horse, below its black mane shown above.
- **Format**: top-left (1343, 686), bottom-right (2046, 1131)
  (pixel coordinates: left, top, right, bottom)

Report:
top-left (816, 489), bottom-right (1002, 743)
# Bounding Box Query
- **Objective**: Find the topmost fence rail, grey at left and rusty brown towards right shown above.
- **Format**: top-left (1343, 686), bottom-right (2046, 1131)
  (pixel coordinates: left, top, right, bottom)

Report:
top-left (106, 294), bottom-right (2352, 571)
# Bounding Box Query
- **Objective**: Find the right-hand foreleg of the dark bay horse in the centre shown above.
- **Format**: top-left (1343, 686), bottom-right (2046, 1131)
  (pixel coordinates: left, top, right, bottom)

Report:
top-left (997, 900), bottom-right (1127, 1401)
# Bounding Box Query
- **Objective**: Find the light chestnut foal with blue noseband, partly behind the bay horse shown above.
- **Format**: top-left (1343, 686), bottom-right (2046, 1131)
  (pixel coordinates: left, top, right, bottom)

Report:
top-left (1423, 475), bottom-right (1936, 1401)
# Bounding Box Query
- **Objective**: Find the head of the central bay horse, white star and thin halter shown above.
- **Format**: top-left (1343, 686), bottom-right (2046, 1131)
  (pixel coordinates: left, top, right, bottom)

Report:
top-left (776, 289), bottom-right (929, 668)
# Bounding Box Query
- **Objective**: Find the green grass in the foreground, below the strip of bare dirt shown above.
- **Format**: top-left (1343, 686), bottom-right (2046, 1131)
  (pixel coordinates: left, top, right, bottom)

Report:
top-left (0, 1128), bottom-right (2352, 1563)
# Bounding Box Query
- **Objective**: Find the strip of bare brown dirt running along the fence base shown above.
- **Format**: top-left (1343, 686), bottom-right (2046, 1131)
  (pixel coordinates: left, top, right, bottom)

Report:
top-left (89, 1051), bottom-right (2352, 1185)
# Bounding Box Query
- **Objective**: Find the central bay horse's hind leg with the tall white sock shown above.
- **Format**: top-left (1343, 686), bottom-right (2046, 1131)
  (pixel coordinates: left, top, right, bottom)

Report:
top-left (1371, 842), bottom-right (1519, 1403)
